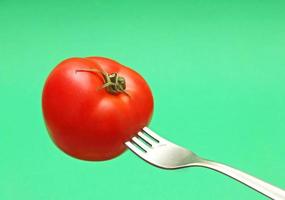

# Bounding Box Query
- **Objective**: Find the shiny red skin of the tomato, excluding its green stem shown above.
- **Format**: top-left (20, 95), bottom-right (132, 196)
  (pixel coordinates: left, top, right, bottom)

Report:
top-left (42, 57), bottom-right (153, 161)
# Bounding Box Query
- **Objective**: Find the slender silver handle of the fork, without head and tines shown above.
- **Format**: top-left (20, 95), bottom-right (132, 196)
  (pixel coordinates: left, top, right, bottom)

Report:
top-left (195, 159), bottom-right (285, 200)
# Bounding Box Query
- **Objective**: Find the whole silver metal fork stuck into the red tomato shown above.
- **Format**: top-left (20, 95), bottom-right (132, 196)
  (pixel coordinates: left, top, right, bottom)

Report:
top-left (125, 127), bottom-right (285, 200)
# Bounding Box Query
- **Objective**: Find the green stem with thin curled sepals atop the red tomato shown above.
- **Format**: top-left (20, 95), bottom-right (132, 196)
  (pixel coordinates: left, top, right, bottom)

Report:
top-left (76, 69), bottom-right (128, 95)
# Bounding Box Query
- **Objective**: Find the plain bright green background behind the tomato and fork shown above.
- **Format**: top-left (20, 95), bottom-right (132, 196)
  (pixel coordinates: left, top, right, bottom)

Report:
top-left (0, 0), bottom-right (285, 200)
